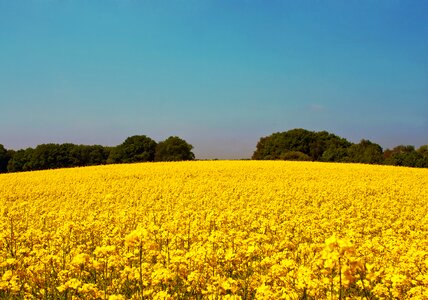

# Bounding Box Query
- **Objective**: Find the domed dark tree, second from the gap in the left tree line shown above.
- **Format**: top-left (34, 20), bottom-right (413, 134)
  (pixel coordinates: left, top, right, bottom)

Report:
top-left (107, 135), bottom-right (157, 163)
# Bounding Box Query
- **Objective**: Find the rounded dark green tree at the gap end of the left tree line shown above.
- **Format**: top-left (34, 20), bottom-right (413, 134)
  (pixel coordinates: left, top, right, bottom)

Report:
top-left (155, 136), bottom-right (195, 161)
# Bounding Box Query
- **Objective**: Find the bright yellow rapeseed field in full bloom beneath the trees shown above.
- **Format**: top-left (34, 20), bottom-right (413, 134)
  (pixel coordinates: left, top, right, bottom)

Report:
top-left (0, 161), bottom-right (428, 299)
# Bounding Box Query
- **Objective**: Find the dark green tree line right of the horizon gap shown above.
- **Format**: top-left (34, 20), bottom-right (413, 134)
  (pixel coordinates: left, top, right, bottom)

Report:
top-left (252, 128), bottom-right (428, 168)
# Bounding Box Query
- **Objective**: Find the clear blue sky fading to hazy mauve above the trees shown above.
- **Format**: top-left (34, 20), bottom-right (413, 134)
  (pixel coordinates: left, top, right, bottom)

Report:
top-left (0, 0), bottom-right (428, 158)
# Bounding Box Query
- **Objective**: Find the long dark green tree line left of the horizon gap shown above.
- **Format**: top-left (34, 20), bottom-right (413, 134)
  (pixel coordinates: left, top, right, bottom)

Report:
top-left (0, 135), bottom-right (195, 173)
